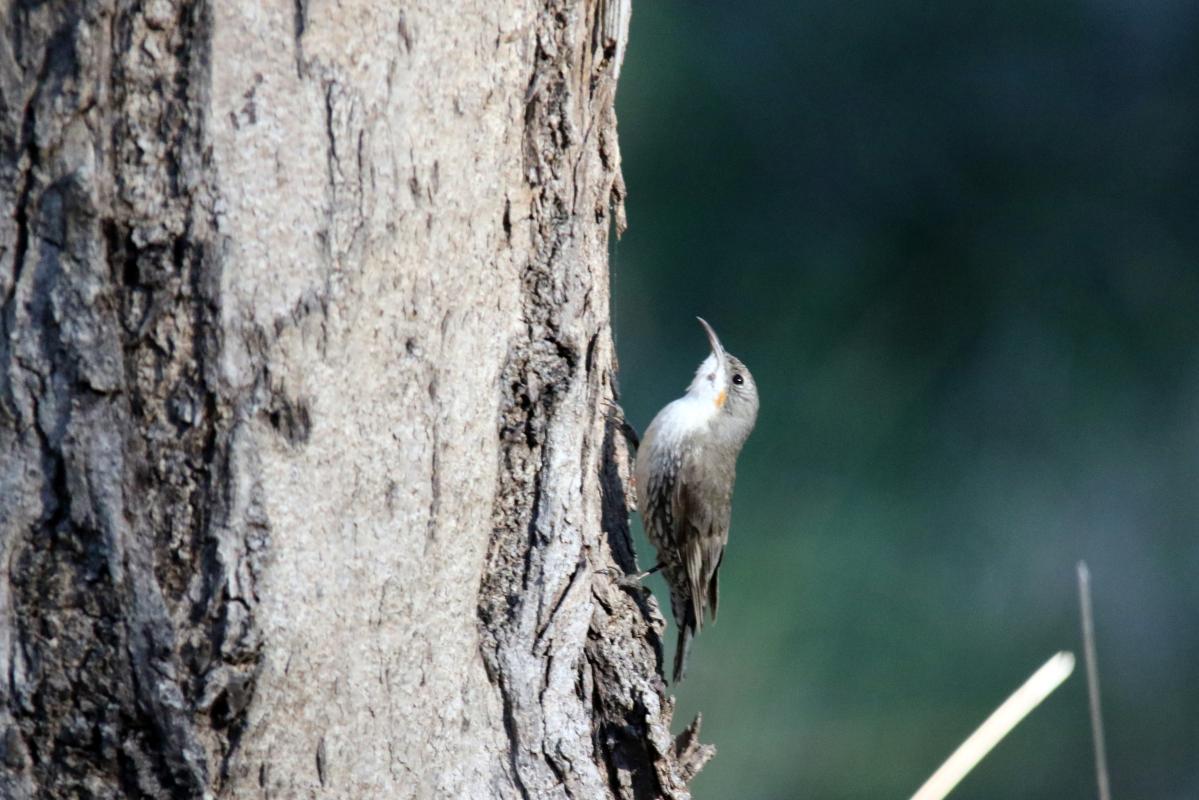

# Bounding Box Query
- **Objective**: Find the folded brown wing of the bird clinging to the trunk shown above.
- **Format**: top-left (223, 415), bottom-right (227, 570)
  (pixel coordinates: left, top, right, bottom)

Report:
top-left (673, 453), bottom-right (730, 626)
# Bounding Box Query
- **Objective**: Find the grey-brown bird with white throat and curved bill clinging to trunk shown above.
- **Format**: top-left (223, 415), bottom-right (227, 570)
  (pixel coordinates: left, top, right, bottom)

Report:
top-left (634, 317), bottom-right (758, 684)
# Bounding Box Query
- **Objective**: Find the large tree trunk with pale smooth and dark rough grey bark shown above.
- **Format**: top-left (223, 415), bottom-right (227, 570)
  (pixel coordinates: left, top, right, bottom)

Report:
top-left (0, 0), bottom-right (712, 799)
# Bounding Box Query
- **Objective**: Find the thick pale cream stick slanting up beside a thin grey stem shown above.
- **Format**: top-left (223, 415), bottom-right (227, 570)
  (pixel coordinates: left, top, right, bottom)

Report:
top-left (911, 652), bottom-right (1074, 800)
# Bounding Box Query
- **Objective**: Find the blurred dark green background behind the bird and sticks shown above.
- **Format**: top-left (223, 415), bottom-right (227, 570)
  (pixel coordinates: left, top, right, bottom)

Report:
top-left (613, 0), bottom-right (1199, 800)
